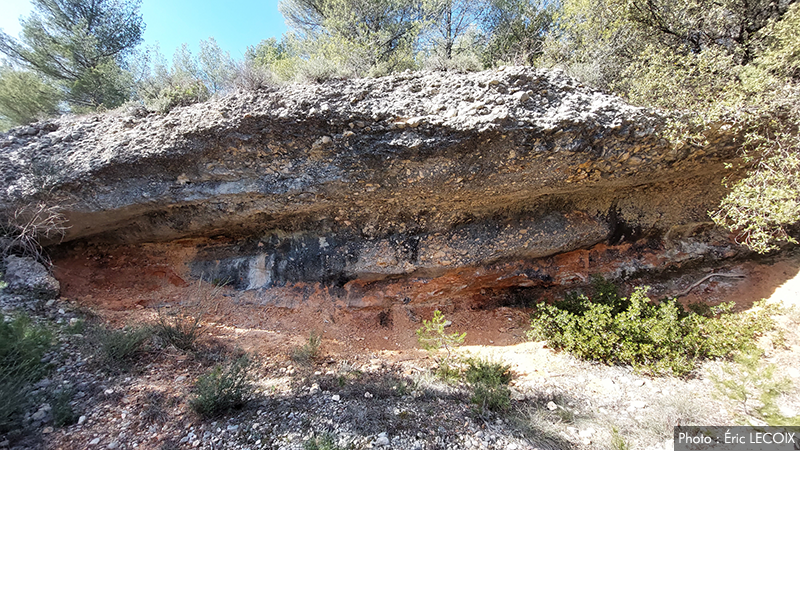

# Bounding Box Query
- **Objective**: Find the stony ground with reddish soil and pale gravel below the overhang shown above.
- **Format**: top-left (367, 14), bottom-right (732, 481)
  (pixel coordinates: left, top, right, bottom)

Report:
top-left (0, 248), bottom-right (800, 449)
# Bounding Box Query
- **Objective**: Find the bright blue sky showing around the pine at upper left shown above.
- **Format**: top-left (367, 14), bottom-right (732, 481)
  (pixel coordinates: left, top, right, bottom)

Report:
top-left (0, 0), bottom-right (286, 58)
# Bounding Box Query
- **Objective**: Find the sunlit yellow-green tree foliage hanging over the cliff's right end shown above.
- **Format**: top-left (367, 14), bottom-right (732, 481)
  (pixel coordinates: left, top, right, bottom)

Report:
top-left (539, 0), bottom-right (800, 253)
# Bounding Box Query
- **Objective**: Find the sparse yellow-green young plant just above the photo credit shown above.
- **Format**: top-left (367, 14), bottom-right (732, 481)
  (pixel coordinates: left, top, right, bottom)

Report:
top-left (711, 348), bottom-right (800, 426)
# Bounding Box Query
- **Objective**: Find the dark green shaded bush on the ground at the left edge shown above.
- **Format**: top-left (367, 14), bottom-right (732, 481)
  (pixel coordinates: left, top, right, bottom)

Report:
top-left (0, 314), bottom-right (53, 432)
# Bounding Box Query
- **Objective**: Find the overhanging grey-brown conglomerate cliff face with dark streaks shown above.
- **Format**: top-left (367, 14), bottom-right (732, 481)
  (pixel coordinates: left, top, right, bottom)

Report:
top-left (0, 68), bottom-right (737, 304)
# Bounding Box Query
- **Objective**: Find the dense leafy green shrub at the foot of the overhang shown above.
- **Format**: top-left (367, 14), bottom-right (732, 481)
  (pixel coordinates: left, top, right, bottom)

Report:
top-left (529, 282), bottom-right (775, 376)
